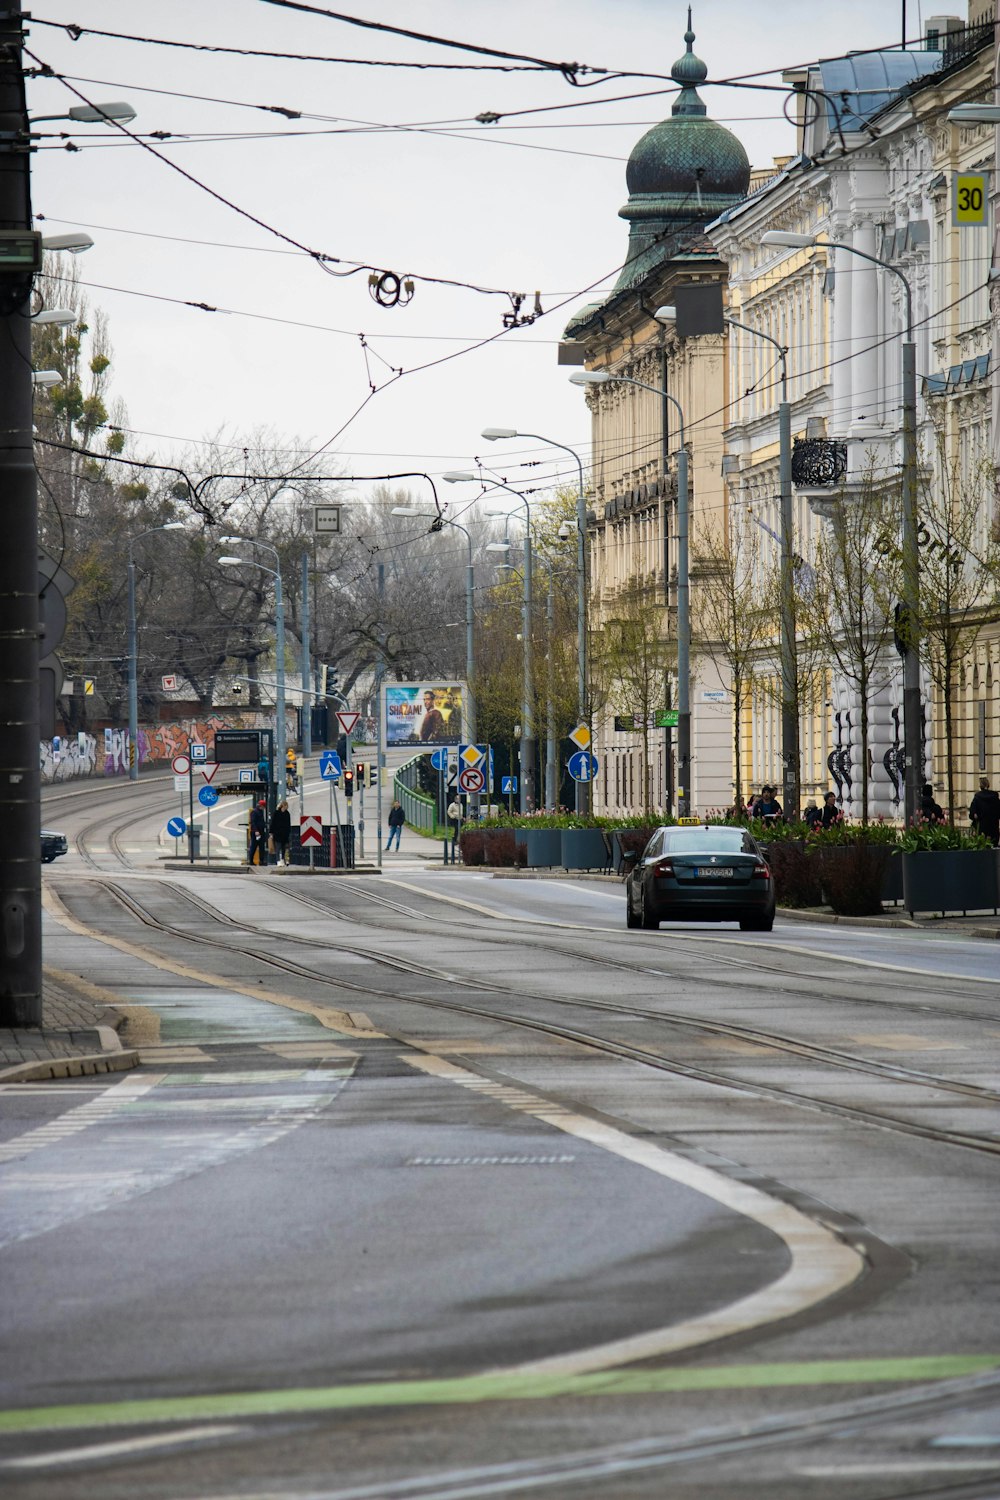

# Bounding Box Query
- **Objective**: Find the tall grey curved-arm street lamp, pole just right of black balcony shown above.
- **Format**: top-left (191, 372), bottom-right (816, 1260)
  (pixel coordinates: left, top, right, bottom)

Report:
top-left (760, 230), bottom-right (924, 825)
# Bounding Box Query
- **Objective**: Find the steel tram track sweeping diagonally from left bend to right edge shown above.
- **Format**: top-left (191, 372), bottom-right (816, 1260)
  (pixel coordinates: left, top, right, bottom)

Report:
top-left (68, 881), bottom-right (1000, 1155)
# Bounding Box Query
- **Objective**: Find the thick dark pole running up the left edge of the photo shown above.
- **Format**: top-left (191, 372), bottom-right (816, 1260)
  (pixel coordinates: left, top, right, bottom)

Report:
top-left (0, 8), bottom-right (41, 1028)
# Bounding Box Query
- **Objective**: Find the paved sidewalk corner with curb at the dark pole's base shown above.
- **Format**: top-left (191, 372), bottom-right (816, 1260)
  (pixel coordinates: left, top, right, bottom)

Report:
top-left (0, 968), bottom-right (139, 1083)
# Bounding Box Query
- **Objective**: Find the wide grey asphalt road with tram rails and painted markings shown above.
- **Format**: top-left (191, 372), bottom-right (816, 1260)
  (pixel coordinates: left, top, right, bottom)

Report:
top-left (7, 786), bottom-right (1000, 1500)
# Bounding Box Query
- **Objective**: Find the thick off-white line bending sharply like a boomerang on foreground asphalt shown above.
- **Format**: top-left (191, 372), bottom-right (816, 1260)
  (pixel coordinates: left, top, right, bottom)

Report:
top-left (403, 1053), bottom-right (867, 1376)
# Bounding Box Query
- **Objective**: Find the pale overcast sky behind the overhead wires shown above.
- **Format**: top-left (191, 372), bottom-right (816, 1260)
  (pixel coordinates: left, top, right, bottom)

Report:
top-left (25, 0), bottom-right (941, 510)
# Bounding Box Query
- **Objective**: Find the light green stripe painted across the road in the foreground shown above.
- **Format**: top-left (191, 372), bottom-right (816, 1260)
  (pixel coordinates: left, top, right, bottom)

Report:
top-left (0, 1355), bottom-right (1000, 1433)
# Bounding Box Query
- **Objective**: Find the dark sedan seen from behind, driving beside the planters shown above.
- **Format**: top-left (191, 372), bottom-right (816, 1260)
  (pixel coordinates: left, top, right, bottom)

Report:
top-left (624, 825), bottom-right (775, 932)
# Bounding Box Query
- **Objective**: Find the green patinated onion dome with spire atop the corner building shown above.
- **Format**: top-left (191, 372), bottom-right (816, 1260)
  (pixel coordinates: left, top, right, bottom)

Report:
top-left (615, 6), bottom-right (750, 291)
